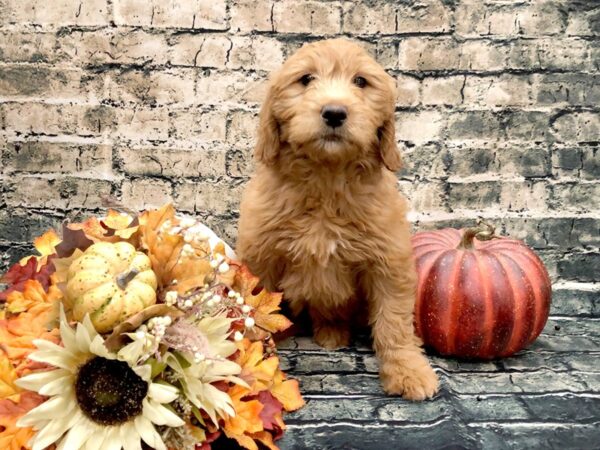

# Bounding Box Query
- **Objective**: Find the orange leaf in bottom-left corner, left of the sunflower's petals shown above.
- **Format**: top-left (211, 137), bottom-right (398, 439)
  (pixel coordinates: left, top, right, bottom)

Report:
top-left (0, 391), bottom-right (45, 450)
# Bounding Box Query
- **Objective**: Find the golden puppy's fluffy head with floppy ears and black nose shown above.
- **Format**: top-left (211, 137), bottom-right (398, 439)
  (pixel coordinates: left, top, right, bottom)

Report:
top-left (256, 39), bottom-right (400, 170)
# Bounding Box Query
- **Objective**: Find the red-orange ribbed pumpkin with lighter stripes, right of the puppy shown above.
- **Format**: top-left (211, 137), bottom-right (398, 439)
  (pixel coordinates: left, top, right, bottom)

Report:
top-left (412, 221), bottom-right (551, 359)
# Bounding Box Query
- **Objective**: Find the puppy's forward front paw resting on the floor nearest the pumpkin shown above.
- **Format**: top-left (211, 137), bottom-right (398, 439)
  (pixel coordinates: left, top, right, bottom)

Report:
top-left (380, 355), bottom-right (439, 401)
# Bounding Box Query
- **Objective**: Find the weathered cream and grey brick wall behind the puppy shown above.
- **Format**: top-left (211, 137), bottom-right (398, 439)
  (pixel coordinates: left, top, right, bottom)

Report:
top-left (0, 0), bottom-right (600, 315)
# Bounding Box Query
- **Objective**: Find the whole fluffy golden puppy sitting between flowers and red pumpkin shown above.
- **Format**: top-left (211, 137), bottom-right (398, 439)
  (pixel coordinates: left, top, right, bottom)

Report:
top-left (237, 39), bottom-right (438, 400)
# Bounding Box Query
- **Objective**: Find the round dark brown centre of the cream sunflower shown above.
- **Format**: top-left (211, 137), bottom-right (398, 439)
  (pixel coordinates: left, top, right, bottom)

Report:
top-left (75, 356), bottom-right (148, 425)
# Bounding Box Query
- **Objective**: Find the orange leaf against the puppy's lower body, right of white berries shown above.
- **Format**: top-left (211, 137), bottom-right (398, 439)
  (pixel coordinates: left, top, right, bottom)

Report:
top-left (233, 266), bottom-right (292, 339)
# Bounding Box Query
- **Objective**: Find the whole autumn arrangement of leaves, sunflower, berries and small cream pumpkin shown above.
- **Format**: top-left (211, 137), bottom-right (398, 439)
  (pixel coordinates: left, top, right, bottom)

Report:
top-left (0, 205), bottom-right (304, 450)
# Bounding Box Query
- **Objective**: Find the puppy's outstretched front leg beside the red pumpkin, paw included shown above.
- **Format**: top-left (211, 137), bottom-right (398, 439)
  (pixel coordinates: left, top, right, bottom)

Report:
top-left (363, 255), bottom-right (439, 400)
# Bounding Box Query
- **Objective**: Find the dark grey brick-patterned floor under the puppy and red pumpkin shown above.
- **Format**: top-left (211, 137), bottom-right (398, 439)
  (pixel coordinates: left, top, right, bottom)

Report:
top-left (279, 317), bottom-right (600, 450)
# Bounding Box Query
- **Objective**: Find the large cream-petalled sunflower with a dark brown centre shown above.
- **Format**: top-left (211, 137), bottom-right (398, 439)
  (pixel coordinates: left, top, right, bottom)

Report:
top-left (16, 308), bottom-right (185, 450)
